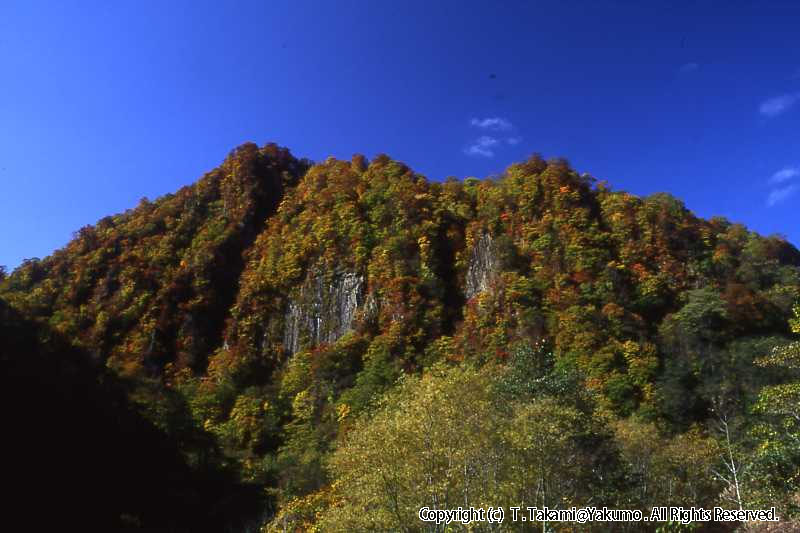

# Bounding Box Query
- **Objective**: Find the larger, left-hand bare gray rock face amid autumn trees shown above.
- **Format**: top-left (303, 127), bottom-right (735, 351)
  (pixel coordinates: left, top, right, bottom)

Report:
top-left (283, 272), bottom-right (365, 354)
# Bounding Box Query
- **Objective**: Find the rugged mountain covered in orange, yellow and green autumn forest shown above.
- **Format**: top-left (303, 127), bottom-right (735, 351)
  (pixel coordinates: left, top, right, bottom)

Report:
top-left (0, 144), bottom-right (800, 530)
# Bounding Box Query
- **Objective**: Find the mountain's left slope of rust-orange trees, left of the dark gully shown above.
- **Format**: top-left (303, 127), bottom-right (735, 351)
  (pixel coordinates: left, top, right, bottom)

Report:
top-left (3, 144), bottom-right (307, 376)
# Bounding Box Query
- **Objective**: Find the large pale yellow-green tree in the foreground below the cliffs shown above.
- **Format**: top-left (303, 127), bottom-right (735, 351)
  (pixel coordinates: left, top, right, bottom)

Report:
top-left (320, 365), bottom-right (501, 531)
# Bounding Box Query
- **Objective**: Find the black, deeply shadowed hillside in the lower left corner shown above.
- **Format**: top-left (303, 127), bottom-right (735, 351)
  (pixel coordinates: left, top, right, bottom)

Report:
top-left (0, 300), bottom-right (263, 532)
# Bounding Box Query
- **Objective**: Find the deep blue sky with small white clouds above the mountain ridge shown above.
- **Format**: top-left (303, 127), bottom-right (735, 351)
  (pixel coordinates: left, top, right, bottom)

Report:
top-left (0, 0), bottom-right (800, 268)
